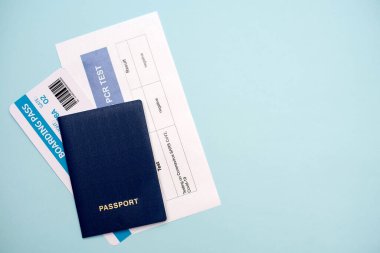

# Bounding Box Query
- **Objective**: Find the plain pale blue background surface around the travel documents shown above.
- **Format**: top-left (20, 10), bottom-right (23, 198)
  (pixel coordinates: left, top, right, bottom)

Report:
top-left (0, 0), bottom-right (380, 253)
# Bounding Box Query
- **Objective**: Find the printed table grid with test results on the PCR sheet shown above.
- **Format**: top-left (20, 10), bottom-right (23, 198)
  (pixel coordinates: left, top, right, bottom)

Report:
top-left (116, 34), bottom-right (197, 201)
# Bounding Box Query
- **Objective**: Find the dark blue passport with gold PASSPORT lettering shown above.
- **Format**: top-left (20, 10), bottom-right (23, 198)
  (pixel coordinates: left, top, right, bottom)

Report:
top-left (58, 100), bottom-right (166, 238)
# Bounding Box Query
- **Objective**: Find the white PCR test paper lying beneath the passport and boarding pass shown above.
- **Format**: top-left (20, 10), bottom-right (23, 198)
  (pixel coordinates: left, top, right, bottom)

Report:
top-left (56, 13), bottom-right (220, 233)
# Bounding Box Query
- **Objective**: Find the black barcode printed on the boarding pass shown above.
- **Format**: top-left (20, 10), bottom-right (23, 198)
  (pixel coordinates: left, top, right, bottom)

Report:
top-left (49, 78), bottom-right (79, 111)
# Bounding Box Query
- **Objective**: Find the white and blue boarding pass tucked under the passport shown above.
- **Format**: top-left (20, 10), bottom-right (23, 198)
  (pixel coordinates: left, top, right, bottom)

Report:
top-left (9, 69), bottom-right (131, 244)
